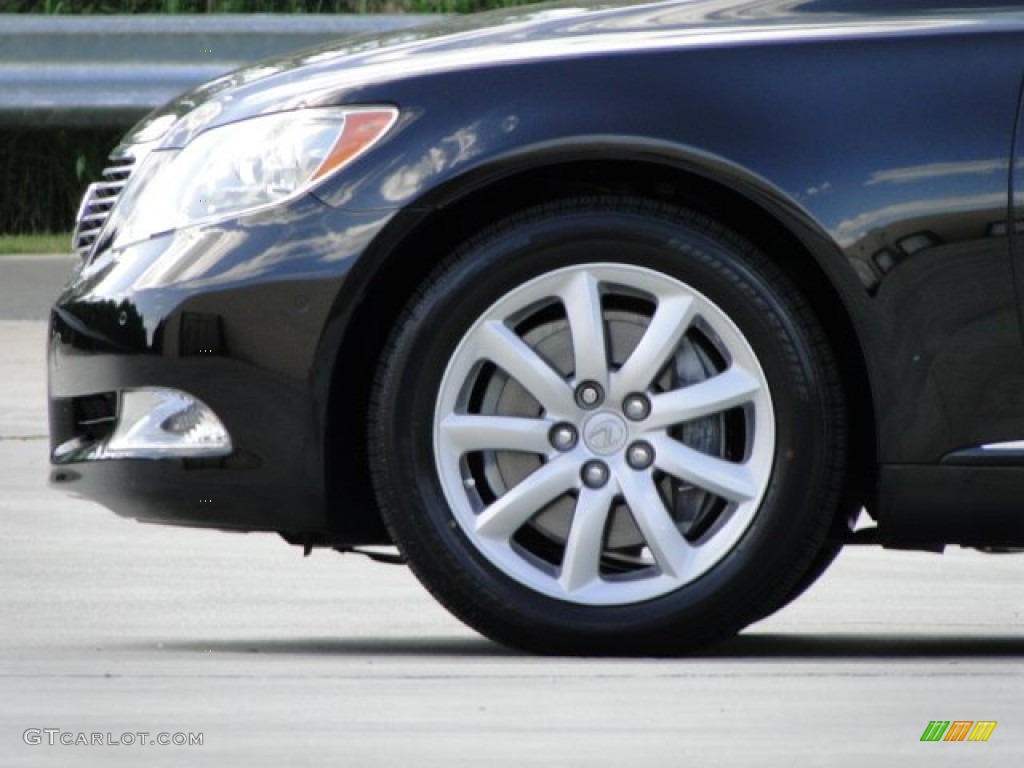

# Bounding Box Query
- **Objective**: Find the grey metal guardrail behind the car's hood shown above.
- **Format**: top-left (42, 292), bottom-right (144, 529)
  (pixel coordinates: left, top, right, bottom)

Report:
top-left (0, 14), bottom-right (437, 127)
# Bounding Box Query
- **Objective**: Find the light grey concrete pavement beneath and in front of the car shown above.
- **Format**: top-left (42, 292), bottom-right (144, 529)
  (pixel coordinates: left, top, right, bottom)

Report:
top-left (0, 257), bottom-right (1024, 768)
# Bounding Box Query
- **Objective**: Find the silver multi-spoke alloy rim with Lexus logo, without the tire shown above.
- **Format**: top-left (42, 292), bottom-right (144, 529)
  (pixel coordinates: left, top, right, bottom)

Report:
top-left (433, 263), bottom-right (775, 605)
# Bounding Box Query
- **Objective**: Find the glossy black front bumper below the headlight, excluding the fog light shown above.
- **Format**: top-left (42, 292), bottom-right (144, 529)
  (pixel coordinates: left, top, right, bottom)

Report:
top-left (48, 200), bottom-right (387, 537)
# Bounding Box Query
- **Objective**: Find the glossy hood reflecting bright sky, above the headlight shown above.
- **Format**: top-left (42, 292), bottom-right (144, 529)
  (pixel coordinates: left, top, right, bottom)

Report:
top-left (123, 0), bottom-right (1019, 146)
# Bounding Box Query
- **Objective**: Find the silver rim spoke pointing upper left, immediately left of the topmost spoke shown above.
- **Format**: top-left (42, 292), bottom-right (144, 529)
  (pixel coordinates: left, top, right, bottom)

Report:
top-left (478, 321), bottom-right (574, 415)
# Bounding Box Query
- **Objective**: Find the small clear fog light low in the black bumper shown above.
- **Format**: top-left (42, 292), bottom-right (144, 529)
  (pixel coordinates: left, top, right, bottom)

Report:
top-left (102, 389), bottom-right (231, 459)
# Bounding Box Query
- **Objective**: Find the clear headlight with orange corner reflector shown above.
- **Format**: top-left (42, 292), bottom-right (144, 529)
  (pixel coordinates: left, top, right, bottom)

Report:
top-left (116, 106), bottom-right (398, 245)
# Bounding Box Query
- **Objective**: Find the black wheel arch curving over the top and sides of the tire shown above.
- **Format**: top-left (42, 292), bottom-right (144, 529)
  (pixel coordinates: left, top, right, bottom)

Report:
top-left (325, 137), bottom-right (878, 545)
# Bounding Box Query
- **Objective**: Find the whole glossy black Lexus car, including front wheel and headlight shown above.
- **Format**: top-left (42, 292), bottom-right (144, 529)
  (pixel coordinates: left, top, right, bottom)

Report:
top-left (49, 0), bottom-right (1024, 653)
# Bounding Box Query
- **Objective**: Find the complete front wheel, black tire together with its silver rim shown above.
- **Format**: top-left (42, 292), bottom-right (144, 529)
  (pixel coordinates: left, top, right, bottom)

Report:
top-left (369, 198), bottom-right (845, 654)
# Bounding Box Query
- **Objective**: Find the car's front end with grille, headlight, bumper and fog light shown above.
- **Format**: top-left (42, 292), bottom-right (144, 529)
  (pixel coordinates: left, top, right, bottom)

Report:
top-left (49, 97), bottom-right (405, 532)
